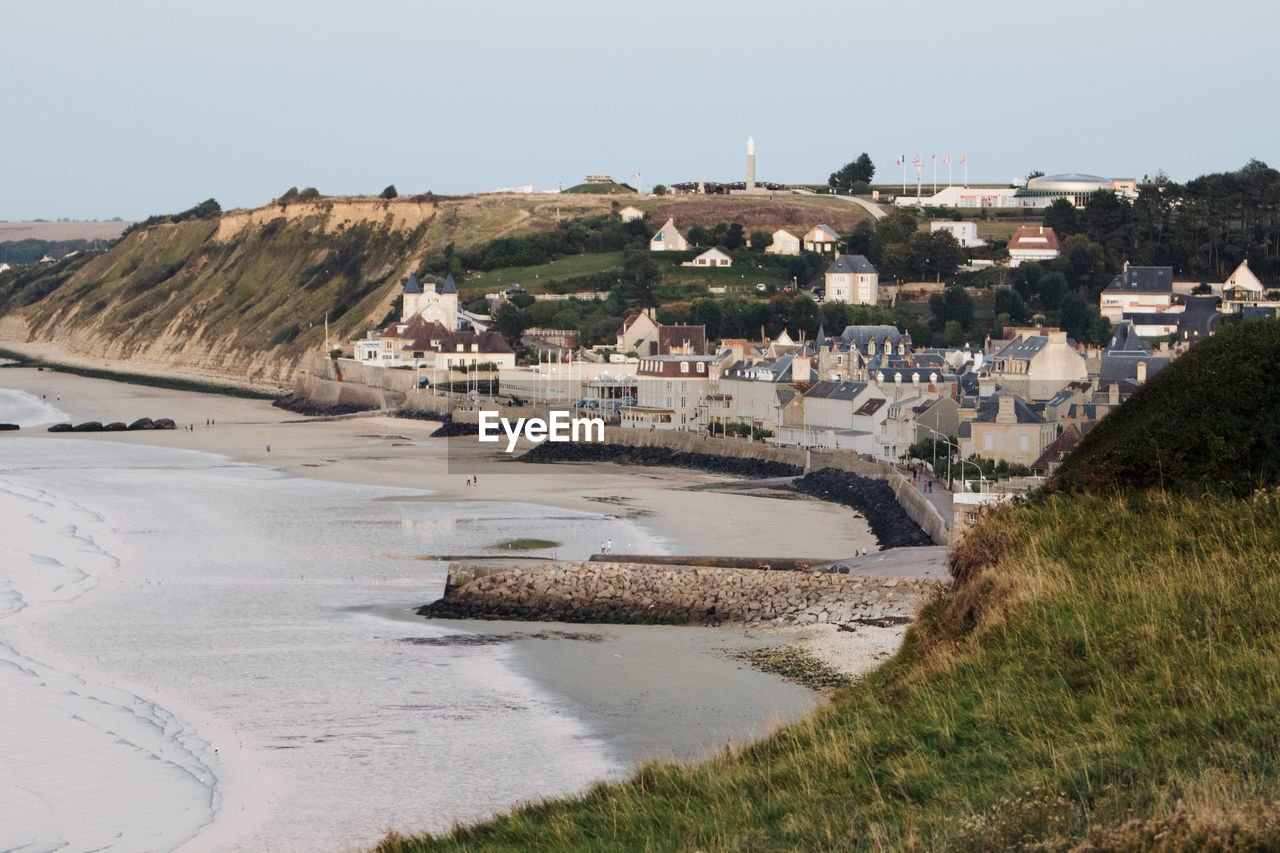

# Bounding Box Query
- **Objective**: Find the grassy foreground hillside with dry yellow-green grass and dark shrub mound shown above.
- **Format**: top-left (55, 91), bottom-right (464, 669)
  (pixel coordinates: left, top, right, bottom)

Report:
top-left (378, 321), bottom-right (1280, 853)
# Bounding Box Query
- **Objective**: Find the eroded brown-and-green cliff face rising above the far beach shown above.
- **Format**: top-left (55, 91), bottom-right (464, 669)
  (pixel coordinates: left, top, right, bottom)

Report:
top-left (0, 196), bottom-right (608, 386)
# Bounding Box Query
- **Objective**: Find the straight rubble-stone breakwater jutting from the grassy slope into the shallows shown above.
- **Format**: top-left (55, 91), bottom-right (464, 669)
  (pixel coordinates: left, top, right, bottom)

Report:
top-left (419, 562), bottom-right (941, 625)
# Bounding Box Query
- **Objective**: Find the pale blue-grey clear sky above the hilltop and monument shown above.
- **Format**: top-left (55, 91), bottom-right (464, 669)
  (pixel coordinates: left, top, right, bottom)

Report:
top-left (0, 0), bottom-right (1280, 220)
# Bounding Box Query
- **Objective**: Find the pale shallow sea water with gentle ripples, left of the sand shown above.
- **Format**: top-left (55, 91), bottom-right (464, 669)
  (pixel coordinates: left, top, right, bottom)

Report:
top-left (0, 389), bottom-right (814, 853)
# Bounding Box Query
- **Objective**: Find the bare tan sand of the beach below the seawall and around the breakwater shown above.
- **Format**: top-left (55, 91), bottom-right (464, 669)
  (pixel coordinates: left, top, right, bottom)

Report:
top-left (0, 368), bottom-right (945, 849)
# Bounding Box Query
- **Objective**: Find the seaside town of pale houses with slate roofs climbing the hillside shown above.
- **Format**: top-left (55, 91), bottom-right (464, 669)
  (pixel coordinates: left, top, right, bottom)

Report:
top-left (333, 142), bottom-right (1280, 530)
